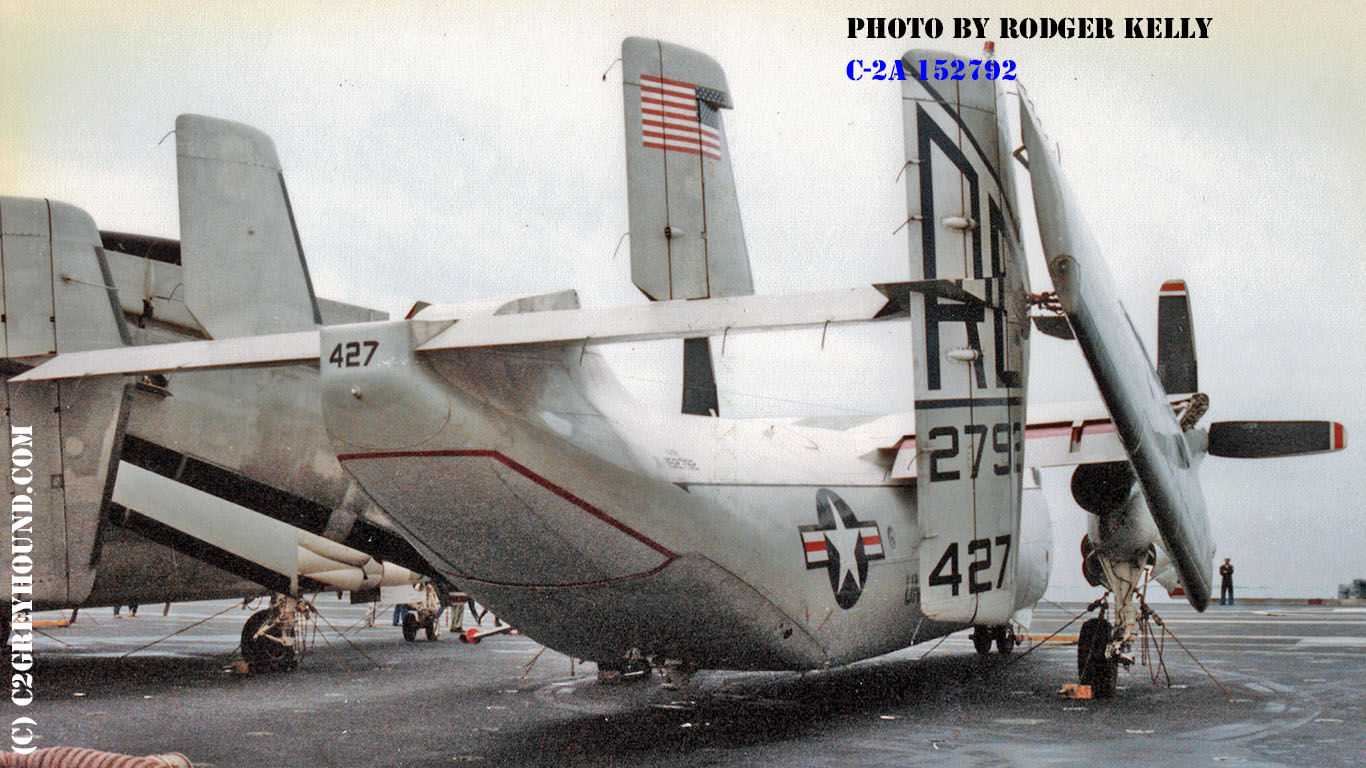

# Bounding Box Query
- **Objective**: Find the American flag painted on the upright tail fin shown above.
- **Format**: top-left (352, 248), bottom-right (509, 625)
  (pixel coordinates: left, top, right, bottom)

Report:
top-left (641, 75), bottom-right (727, 160)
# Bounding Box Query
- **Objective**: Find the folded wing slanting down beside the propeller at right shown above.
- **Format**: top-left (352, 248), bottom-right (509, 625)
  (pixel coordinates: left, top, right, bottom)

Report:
top-left (1020, 92), bottom-right (1214, 611)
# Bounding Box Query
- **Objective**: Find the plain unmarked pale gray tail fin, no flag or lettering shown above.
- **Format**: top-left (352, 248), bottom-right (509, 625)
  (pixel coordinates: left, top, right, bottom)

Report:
top-left (175, 115), bottom-right (321, 339)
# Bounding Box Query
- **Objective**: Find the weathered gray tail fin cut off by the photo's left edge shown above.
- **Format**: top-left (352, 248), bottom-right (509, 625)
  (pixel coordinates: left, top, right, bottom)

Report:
top-left (0, 197), bottom-right (128, 604)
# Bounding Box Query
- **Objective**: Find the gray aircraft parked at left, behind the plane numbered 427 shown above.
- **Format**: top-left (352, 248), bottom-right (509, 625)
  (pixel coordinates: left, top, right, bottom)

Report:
top-left (0, 116), bottom-right (436, 668)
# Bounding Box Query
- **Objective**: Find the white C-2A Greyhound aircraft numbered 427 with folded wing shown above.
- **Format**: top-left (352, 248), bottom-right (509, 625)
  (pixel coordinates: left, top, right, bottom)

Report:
top-left (20, 38), bottom-right (1343, 696)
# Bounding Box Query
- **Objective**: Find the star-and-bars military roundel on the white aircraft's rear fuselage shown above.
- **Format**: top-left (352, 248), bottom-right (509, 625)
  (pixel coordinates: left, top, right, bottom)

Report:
top-left (798, 488), bottom-right (887, 611)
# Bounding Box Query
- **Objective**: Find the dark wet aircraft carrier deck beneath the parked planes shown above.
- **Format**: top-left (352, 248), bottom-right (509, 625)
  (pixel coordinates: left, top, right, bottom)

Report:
top-left (21, 597), bottom-right (1366, 768)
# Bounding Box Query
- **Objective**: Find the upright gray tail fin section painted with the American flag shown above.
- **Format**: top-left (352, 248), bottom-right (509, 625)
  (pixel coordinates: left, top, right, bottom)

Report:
top-left (622, 37), bottom-right (754, 301)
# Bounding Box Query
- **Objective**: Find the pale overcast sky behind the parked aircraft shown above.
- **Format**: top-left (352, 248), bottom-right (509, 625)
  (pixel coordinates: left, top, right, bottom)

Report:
top-left (0, 0), bottom-right (1366, 596)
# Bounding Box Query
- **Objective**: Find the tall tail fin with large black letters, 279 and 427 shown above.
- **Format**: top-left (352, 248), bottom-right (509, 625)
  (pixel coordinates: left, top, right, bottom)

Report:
top-left (902, 51), bottom-right (1029, 625)
